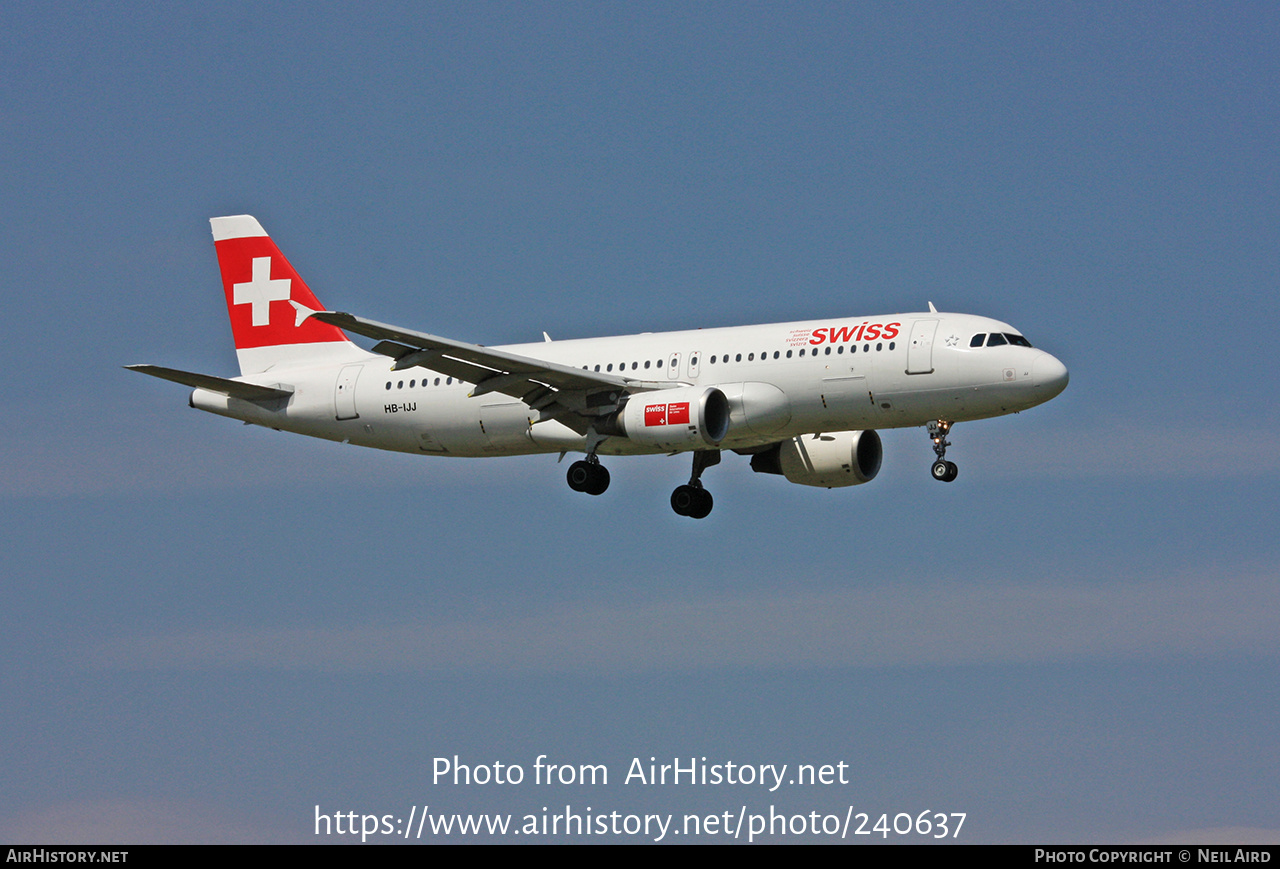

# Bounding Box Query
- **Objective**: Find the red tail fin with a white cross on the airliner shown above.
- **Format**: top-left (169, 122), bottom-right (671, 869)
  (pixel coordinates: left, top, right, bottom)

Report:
top-left (209, 214), bottom-right (361, 374)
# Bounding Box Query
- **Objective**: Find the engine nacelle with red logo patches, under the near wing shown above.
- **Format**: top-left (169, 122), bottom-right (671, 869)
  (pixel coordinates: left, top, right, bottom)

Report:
top-left (618, 387), bottom-right (730, 449)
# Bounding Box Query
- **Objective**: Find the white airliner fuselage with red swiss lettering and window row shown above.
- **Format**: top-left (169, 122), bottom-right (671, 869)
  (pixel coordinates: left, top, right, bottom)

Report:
top-left (191, 312), bottom-right (1066, 456)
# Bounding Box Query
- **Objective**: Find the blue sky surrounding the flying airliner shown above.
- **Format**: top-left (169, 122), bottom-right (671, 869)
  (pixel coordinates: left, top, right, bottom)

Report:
top-left (0, 4), bottom-right (1280, 842)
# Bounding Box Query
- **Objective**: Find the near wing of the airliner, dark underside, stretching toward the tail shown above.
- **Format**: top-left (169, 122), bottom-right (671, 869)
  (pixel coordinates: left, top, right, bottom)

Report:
top-left (311, 311), bottom-right (666, 427)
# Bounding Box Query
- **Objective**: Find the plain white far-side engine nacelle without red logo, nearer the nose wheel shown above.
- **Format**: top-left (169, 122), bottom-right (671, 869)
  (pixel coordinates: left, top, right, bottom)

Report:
top-left (751, 431), bottom-right (884, 489)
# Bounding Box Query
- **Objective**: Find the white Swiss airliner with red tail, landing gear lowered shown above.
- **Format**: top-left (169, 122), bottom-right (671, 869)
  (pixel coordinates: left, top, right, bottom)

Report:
top-left (125, 215), bottom-right (1069, 518)
